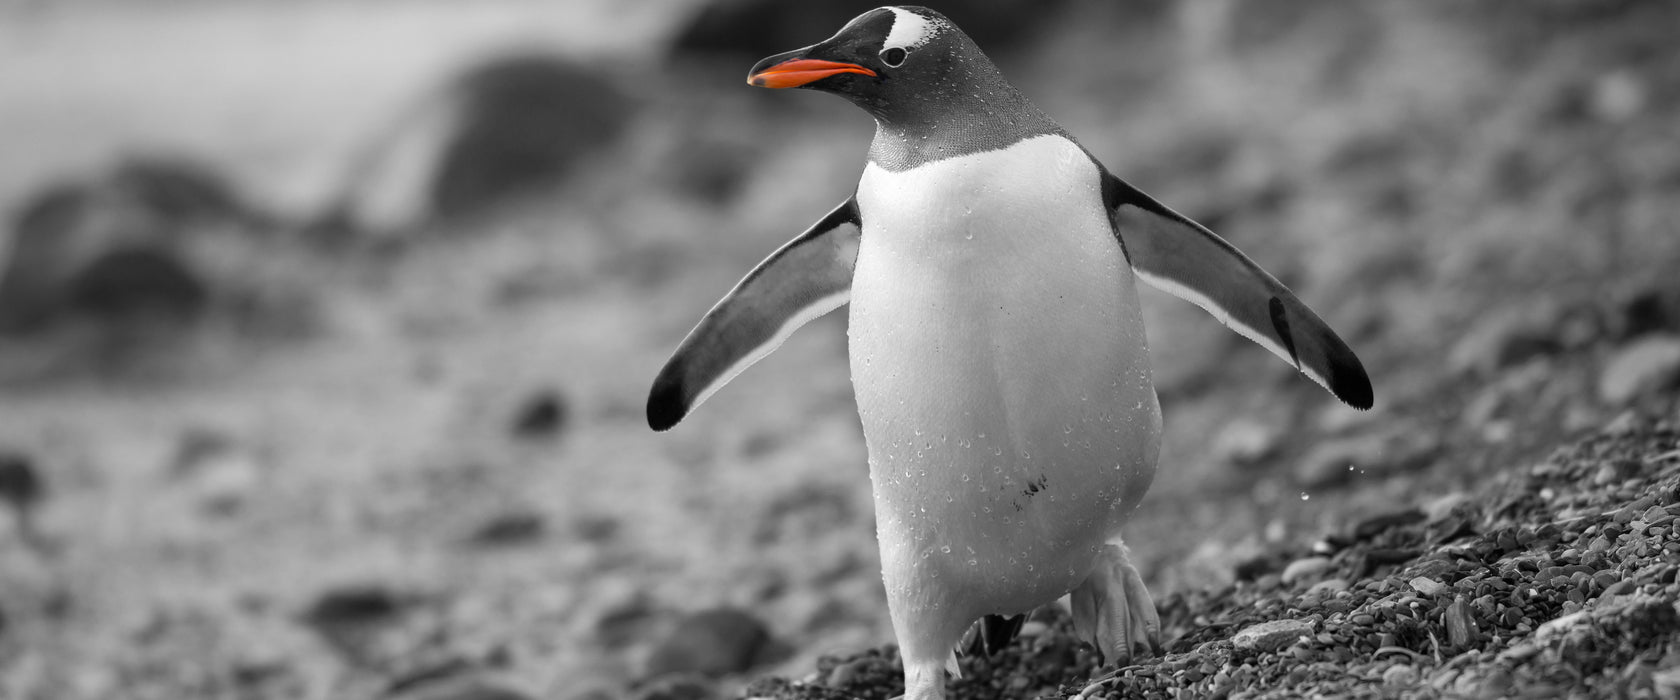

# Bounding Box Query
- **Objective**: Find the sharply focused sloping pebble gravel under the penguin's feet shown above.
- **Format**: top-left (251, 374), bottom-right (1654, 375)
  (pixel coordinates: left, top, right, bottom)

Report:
top-left (748, 417), bottom-right (1680, 700)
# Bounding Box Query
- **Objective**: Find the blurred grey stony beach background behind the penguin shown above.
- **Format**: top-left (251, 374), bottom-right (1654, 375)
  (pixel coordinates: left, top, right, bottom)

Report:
top-left (0, 0), bottom-right (1680, 698)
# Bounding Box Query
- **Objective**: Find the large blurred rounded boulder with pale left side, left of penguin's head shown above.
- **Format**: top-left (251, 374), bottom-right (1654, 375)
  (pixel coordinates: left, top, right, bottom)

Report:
top-left (330, 54), bottom-right (633, 233)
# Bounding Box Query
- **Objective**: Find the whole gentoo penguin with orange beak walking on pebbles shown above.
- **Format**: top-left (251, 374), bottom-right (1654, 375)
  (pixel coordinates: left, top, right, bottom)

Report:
top-left (647, 7), bottom-right (1373, 700)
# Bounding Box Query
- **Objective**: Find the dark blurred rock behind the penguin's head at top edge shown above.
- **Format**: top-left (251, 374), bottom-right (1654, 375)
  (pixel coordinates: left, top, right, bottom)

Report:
top-left (672, 0), bottom-right (1075, 60)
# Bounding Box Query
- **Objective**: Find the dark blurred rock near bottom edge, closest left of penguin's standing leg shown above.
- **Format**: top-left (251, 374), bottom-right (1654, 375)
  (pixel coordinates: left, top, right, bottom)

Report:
top-left (647, 608), bottom-right (769, 678)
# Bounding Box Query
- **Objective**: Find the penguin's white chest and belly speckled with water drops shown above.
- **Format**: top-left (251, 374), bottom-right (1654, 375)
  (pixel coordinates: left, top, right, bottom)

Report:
top-left (848, 136), bottom-right (1161, 616)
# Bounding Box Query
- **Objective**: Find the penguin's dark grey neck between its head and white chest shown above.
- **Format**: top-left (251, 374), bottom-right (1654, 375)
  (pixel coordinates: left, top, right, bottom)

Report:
top-left (865, 62), bottom-right (1063, 173)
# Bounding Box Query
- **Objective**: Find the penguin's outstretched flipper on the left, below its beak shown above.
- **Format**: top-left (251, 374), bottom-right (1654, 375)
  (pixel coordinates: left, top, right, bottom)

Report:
top-left (647, 198), bottom-right (862, 430)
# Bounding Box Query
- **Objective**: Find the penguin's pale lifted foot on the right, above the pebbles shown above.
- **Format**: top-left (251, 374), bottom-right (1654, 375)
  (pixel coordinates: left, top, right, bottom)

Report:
top-left (1070, 542), bottom-right (1161, 664)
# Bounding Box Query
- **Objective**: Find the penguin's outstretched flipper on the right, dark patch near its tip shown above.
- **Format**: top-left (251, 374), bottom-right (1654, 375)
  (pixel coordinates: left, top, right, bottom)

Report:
top-left (1102, 173), bottom-right (1373, 410)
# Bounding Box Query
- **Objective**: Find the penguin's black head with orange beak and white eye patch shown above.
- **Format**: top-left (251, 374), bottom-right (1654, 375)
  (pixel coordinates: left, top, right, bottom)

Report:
top-left (746, 7), bottom-right (974, 118)
